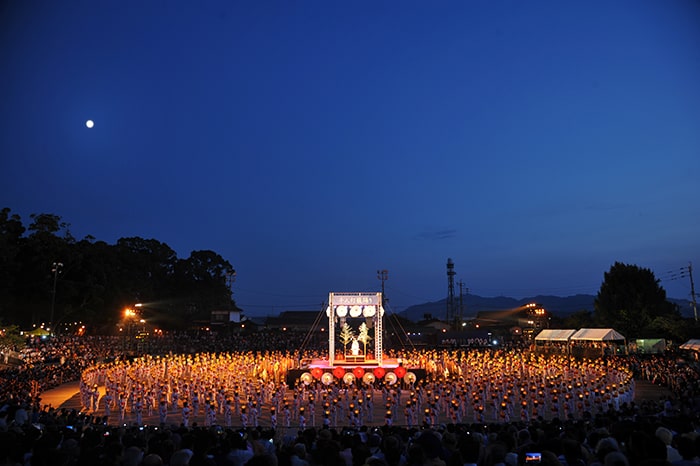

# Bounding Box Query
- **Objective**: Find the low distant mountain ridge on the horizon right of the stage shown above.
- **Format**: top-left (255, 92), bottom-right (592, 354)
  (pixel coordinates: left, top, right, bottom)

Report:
top-left (399, 294), bottom-right (693, 321)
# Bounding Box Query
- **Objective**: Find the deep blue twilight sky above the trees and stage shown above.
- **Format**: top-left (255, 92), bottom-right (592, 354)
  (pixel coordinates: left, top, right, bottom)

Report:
top-left (0, 0), bottom-right (700, 315)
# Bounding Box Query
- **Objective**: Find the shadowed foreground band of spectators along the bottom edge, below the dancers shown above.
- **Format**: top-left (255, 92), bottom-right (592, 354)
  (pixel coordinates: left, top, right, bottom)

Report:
top-left (0, 404), bottom-right (700, 466)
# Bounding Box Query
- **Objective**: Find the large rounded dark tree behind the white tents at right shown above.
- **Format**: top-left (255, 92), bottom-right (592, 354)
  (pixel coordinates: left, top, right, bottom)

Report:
top-left (594, 262), bottom-right (680, 338)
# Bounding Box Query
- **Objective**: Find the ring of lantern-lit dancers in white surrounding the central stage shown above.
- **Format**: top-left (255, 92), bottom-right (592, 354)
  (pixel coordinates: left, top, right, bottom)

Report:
top-left (80, 349), bottom-right (634, 429)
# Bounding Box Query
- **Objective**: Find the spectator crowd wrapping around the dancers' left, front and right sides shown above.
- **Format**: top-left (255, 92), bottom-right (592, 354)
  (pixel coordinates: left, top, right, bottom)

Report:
top-left (0, 337), bottom-right (700, 466)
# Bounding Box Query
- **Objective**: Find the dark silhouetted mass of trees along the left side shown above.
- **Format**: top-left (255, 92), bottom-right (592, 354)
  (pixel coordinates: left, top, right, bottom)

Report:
top-left (0, 208), bottom-right (235, 334)
